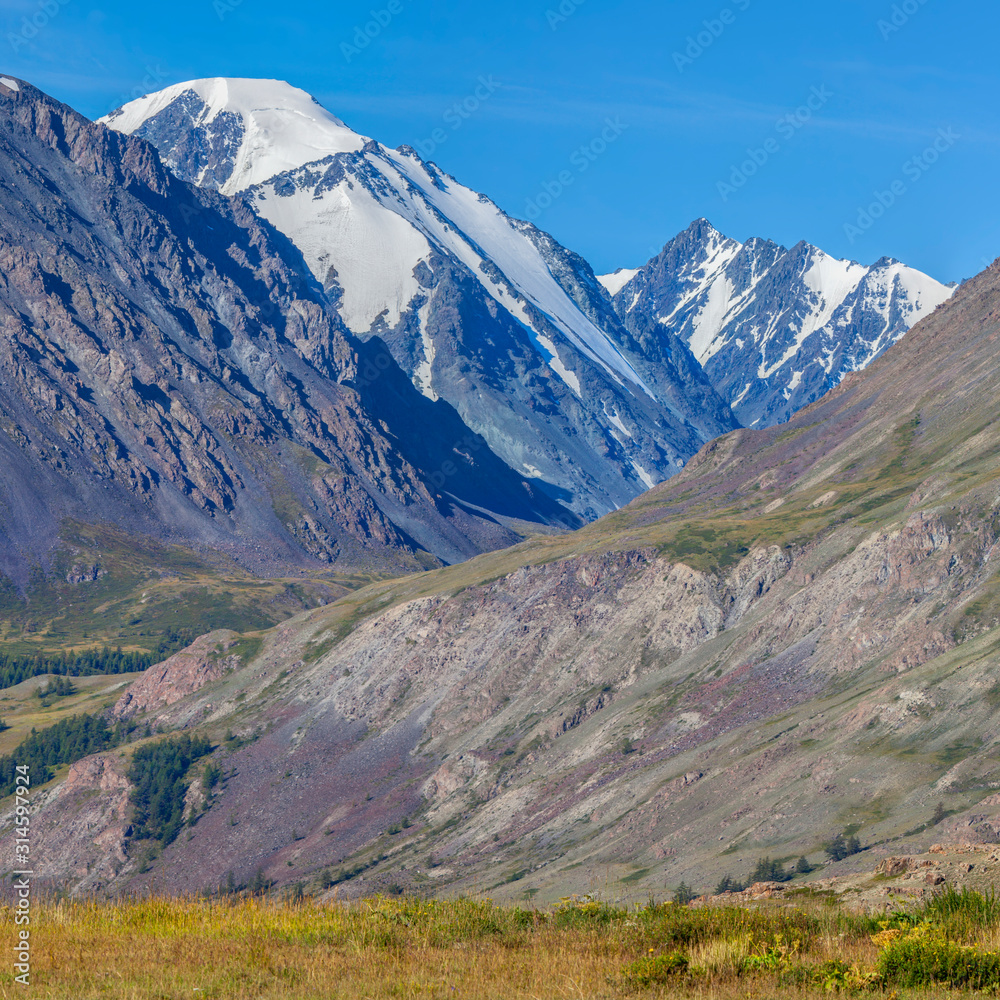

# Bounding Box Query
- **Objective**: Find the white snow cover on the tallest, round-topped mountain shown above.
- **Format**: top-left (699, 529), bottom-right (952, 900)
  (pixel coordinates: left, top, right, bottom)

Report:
top-left (101, 78), bottom-right (656, 399)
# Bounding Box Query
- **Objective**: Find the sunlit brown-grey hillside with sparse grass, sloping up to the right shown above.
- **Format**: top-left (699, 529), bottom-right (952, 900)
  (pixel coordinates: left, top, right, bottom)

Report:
top-left (17, 248), bottom-right (1000, 899)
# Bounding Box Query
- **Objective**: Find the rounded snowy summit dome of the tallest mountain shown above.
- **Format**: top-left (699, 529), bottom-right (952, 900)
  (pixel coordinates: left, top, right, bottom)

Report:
top-left (100, 77), bottom-right (368, 194)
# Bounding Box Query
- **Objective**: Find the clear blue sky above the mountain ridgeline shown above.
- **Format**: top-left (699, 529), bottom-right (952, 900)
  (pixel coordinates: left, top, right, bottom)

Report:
top-left (0, 0), bottom-right (1000, 280)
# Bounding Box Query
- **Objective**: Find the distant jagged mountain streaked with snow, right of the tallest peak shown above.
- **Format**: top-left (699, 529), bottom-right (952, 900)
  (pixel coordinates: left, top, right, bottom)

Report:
top-left (600, 219), bottom-right (954, 427)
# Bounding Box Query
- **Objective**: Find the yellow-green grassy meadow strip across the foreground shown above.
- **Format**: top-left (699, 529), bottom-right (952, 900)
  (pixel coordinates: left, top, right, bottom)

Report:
top-left (0, 890), bottom-right (1000, 1000)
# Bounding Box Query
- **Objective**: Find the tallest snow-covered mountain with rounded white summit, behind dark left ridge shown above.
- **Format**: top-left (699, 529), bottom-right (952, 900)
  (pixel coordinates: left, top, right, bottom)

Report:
top-left (105, 79), bottom-right (736, 518)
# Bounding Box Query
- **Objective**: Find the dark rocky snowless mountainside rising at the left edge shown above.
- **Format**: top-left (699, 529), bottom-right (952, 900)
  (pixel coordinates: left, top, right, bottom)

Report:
top-left (0, 82), bottom-right (576, 584)
